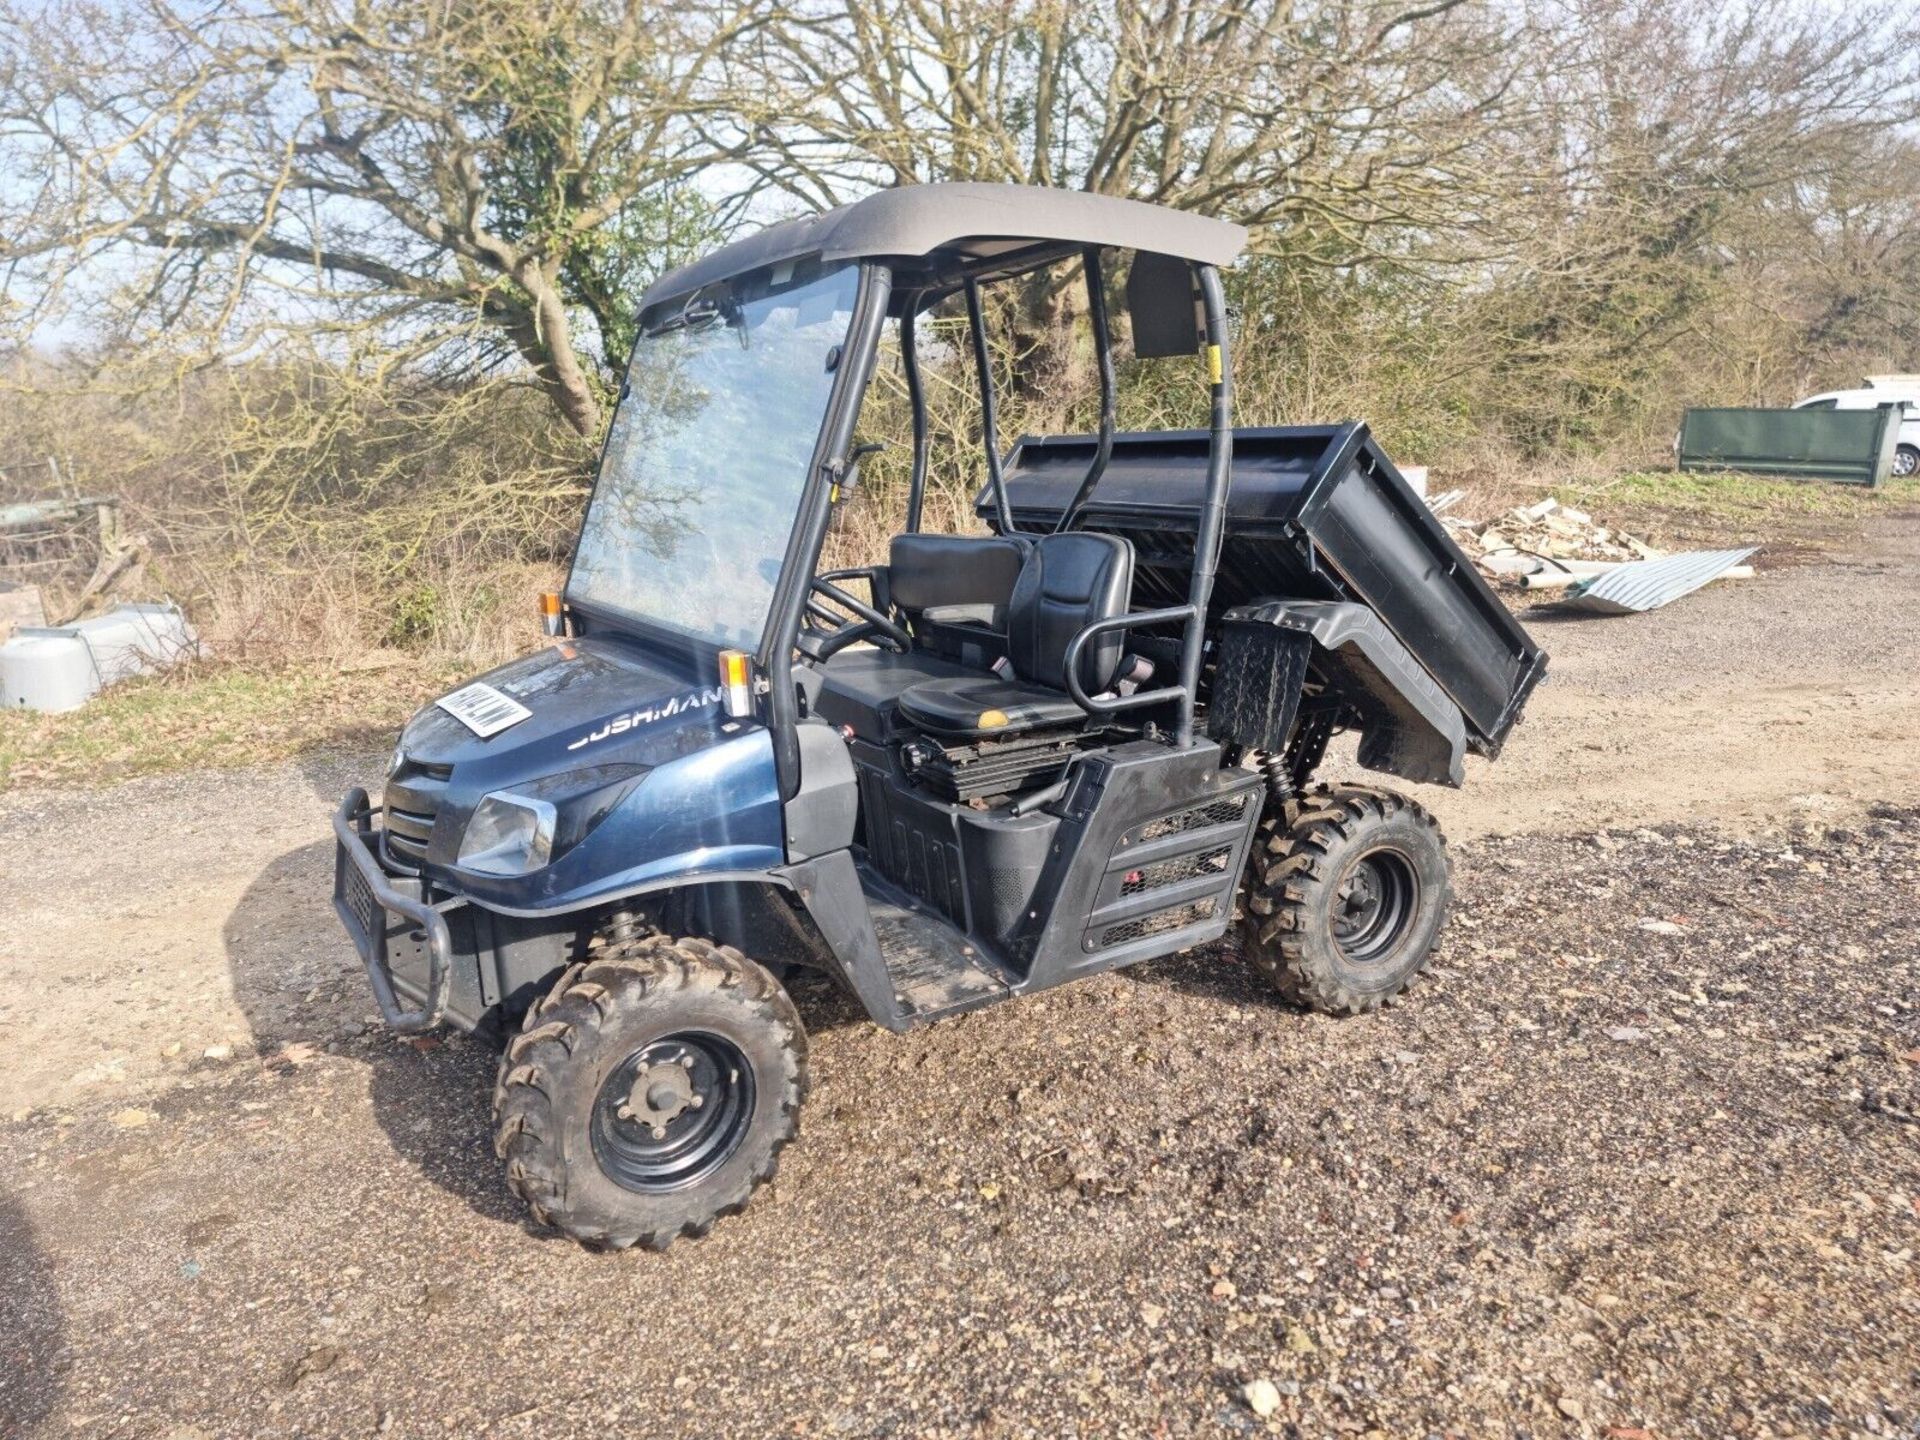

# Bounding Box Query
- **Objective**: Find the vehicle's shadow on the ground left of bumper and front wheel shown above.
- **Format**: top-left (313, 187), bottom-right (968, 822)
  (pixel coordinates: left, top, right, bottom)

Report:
top-left (223, 839), bottom-right (526, 1225)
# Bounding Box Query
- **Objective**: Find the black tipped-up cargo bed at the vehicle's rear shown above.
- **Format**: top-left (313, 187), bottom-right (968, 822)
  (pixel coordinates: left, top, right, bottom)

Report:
top-left (977, 420), bottom-right (1546, 755)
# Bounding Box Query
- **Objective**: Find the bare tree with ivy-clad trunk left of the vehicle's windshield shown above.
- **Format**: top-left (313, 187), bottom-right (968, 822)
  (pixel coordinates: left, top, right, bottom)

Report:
top-left (0, 0), bottom-right (764, 436)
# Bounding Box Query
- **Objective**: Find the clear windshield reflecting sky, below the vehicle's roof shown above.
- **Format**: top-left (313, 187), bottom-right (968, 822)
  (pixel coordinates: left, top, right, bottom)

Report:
top-left (566, 265), bottom-right (860, 649)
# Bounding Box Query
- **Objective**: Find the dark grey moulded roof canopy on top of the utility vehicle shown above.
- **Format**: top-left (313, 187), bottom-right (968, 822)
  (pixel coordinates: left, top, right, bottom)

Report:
top-left (639, 182), bottom-right (1246, 313)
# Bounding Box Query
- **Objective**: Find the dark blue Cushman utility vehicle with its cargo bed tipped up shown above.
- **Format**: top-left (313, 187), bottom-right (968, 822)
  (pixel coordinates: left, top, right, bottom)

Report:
top-left (334, 184), bottom-right (1546, 1248)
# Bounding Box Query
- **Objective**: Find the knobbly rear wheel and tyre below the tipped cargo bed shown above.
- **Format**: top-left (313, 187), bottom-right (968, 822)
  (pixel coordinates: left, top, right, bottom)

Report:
top-left (1240, 785), bottom-right (1452, 1016)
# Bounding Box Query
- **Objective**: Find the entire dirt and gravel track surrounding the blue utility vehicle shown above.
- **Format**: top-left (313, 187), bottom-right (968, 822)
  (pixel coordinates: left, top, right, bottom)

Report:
top-left (0, 503), bottom-right (1920, 1436)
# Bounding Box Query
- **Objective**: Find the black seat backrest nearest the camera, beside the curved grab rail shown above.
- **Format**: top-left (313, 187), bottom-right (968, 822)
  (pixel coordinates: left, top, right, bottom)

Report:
top-left (1006, 530), bottom-right (1133, 695)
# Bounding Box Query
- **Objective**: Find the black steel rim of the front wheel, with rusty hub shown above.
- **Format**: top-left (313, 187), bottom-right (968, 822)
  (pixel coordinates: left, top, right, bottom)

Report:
top-left (589, 1031), bottom-right (755, 1192)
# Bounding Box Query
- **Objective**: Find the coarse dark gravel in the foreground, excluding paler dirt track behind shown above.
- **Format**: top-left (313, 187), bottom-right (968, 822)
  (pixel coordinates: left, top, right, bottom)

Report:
top-left (0, 806), bottom-right (1920, 1436)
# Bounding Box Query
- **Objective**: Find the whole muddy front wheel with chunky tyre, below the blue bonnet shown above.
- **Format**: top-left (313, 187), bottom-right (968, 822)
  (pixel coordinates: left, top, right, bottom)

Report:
top-left (493, 935), bottom-right (806, 1250)
